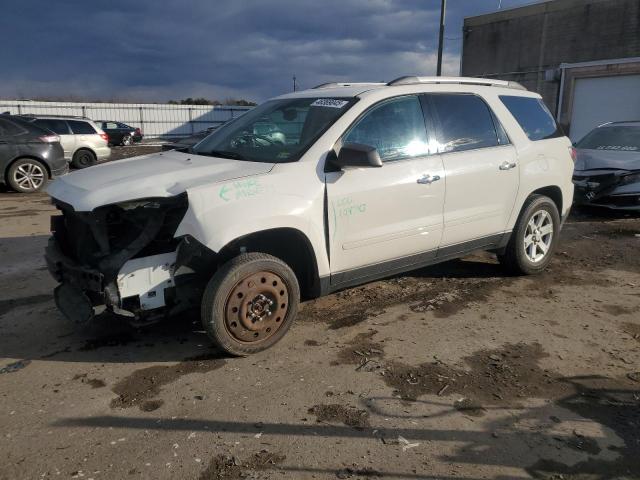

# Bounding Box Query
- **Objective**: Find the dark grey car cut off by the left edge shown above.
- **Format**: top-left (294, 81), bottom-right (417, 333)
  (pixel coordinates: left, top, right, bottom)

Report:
top-left (0, 114), bottom-right (68, 193)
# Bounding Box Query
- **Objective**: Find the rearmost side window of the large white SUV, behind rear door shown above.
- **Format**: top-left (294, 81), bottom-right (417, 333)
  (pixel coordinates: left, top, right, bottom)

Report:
top-left (500, 95), bottom-right (564, 140)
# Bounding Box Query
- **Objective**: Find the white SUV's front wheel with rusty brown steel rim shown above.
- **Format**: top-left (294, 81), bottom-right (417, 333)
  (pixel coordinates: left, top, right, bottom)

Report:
top-left (202, 253), bottom-right (300, 356)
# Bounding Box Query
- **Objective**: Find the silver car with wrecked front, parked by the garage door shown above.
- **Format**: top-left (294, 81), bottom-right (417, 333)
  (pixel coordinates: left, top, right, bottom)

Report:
top-left (573, 121), bottom-right (640, 211)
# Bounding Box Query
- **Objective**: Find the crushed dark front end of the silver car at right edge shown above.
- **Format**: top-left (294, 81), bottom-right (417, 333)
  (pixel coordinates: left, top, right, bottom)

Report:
top-left (573, 169), bottom-right (640, 210)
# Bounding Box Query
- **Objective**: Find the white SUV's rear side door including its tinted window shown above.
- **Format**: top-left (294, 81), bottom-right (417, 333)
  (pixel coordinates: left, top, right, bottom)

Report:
top-left (423, 93), bottom-right (519, 248)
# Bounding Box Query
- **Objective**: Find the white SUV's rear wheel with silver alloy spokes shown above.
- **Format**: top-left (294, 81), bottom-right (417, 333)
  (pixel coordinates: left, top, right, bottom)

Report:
top-left (498, 195), bottom-right (560, 275)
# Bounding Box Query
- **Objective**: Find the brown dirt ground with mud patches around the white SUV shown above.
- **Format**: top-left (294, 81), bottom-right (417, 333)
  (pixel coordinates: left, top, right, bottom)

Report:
top-left (0, 148), bottom-right (640, 480)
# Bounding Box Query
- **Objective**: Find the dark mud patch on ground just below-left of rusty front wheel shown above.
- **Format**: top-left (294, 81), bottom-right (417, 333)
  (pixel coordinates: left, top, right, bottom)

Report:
top-left (111, 354), bottom-right (226, 411)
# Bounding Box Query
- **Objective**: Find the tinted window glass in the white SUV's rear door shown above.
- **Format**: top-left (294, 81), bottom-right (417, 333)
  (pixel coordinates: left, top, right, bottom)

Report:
top-left (429, 94), bottom-right (499, 153)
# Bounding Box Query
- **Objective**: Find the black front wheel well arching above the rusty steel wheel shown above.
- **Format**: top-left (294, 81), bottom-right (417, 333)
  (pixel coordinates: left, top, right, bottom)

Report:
top-left (218, 228), bottom-right (320, 300)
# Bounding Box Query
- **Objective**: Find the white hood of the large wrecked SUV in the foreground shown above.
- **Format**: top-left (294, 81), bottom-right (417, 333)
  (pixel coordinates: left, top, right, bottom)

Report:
top-left (47, 151), bottom-right (274, 211)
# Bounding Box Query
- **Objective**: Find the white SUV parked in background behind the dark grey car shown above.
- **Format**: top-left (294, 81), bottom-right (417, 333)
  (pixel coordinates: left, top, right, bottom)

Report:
top-left (23, 115), bottom-right (111, 168)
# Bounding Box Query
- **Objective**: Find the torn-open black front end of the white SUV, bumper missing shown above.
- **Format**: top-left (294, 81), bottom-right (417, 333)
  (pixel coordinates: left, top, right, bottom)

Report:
top-left (45, 193), bottom-right (213, 324)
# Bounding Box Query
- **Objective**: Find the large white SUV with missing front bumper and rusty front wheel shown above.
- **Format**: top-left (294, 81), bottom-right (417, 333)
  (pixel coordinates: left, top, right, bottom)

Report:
top-left (46, 77), bottom-right (573, 355)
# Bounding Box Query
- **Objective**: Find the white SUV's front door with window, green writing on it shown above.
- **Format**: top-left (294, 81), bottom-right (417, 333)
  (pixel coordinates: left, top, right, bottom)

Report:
top-left (326, 95), bottom-right (445, 285)
